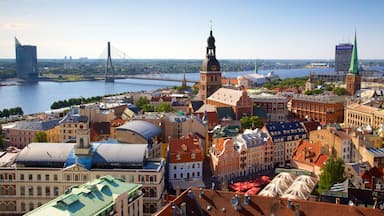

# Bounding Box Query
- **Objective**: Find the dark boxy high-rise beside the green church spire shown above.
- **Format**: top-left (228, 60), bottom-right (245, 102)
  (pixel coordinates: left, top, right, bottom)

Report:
top-left (335, 43), bottom-right (353, 72)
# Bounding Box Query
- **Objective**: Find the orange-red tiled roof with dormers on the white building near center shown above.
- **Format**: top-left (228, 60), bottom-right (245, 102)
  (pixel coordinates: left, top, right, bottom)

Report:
top-left (169, 136), bottom-right (203, 163)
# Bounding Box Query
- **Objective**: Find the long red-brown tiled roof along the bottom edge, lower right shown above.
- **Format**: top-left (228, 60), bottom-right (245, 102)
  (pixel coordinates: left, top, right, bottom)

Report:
top-left (154, 188), bottom-right (383, 216)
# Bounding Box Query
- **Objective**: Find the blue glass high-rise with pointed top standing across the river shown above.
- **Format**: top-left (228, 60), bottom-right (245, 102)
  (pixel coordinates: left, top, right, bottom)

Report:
top-left (15, 37), bottom-right (39, 81)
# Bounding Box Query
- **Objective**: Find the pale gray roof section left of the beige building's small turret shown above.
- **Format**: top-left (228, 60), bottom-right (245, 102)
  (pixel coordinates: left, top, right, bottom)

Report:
top-left (16, 143), bottom-right (75, 163)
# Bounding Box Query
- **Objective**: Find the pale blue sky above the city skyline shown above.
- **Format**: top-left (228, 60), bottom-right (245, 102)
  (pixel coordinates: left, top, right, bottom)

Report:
top-left (0, 0), bottom-right (384, 59)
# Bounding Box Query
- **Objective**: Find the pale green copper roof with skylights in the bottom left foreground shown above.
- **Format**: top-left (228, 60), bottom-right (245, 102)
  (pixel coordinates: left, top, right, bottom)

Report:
top-left (25, 176), bottom-right (141, 216)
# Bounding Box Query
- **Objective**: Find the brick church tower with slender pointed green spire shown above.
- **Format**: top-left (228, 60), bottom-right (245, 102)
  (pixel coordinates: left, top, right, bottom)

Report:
top-left (345, 32), bottom-right (361, 96)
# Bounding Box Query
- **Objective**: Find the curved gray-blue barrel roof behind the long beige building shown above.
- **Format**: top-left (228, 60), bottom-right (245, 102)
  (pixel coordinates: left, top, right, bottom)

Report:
top-left (116, 120), bottom-right (161, 140)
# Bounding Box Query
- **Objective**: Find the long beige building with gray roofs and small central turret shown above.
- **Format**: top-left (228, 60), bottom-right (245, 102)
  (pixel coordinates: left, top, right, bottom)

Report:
top-left (0, 129), bottom-right (165, 215)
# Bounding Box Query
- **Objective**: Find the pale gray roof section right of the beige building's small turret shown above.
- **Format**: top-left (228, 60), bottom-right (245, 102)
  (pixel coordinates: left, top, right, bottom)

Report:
top-left (93, 144), bottom-right (147, 163)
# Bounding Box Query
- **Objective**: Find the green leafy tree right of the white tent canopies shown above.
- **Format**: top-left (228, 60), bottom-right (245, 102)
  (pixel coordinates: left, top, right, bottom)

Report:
top-left (319, 157), bottom-right (345, 193)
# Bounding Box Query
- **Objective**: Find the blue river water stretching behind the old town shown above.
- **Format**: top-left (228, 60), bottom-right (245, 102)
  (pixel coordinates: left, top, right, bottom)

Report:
top-left (0, 68), bottom-right (333, 114)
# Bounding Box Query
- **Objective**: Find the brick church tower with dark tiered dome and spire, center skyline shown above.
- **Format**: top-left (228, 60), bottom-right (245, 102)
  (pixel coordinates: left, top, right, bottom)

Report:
top-left (200, 29), bottom-right (221, 101)
